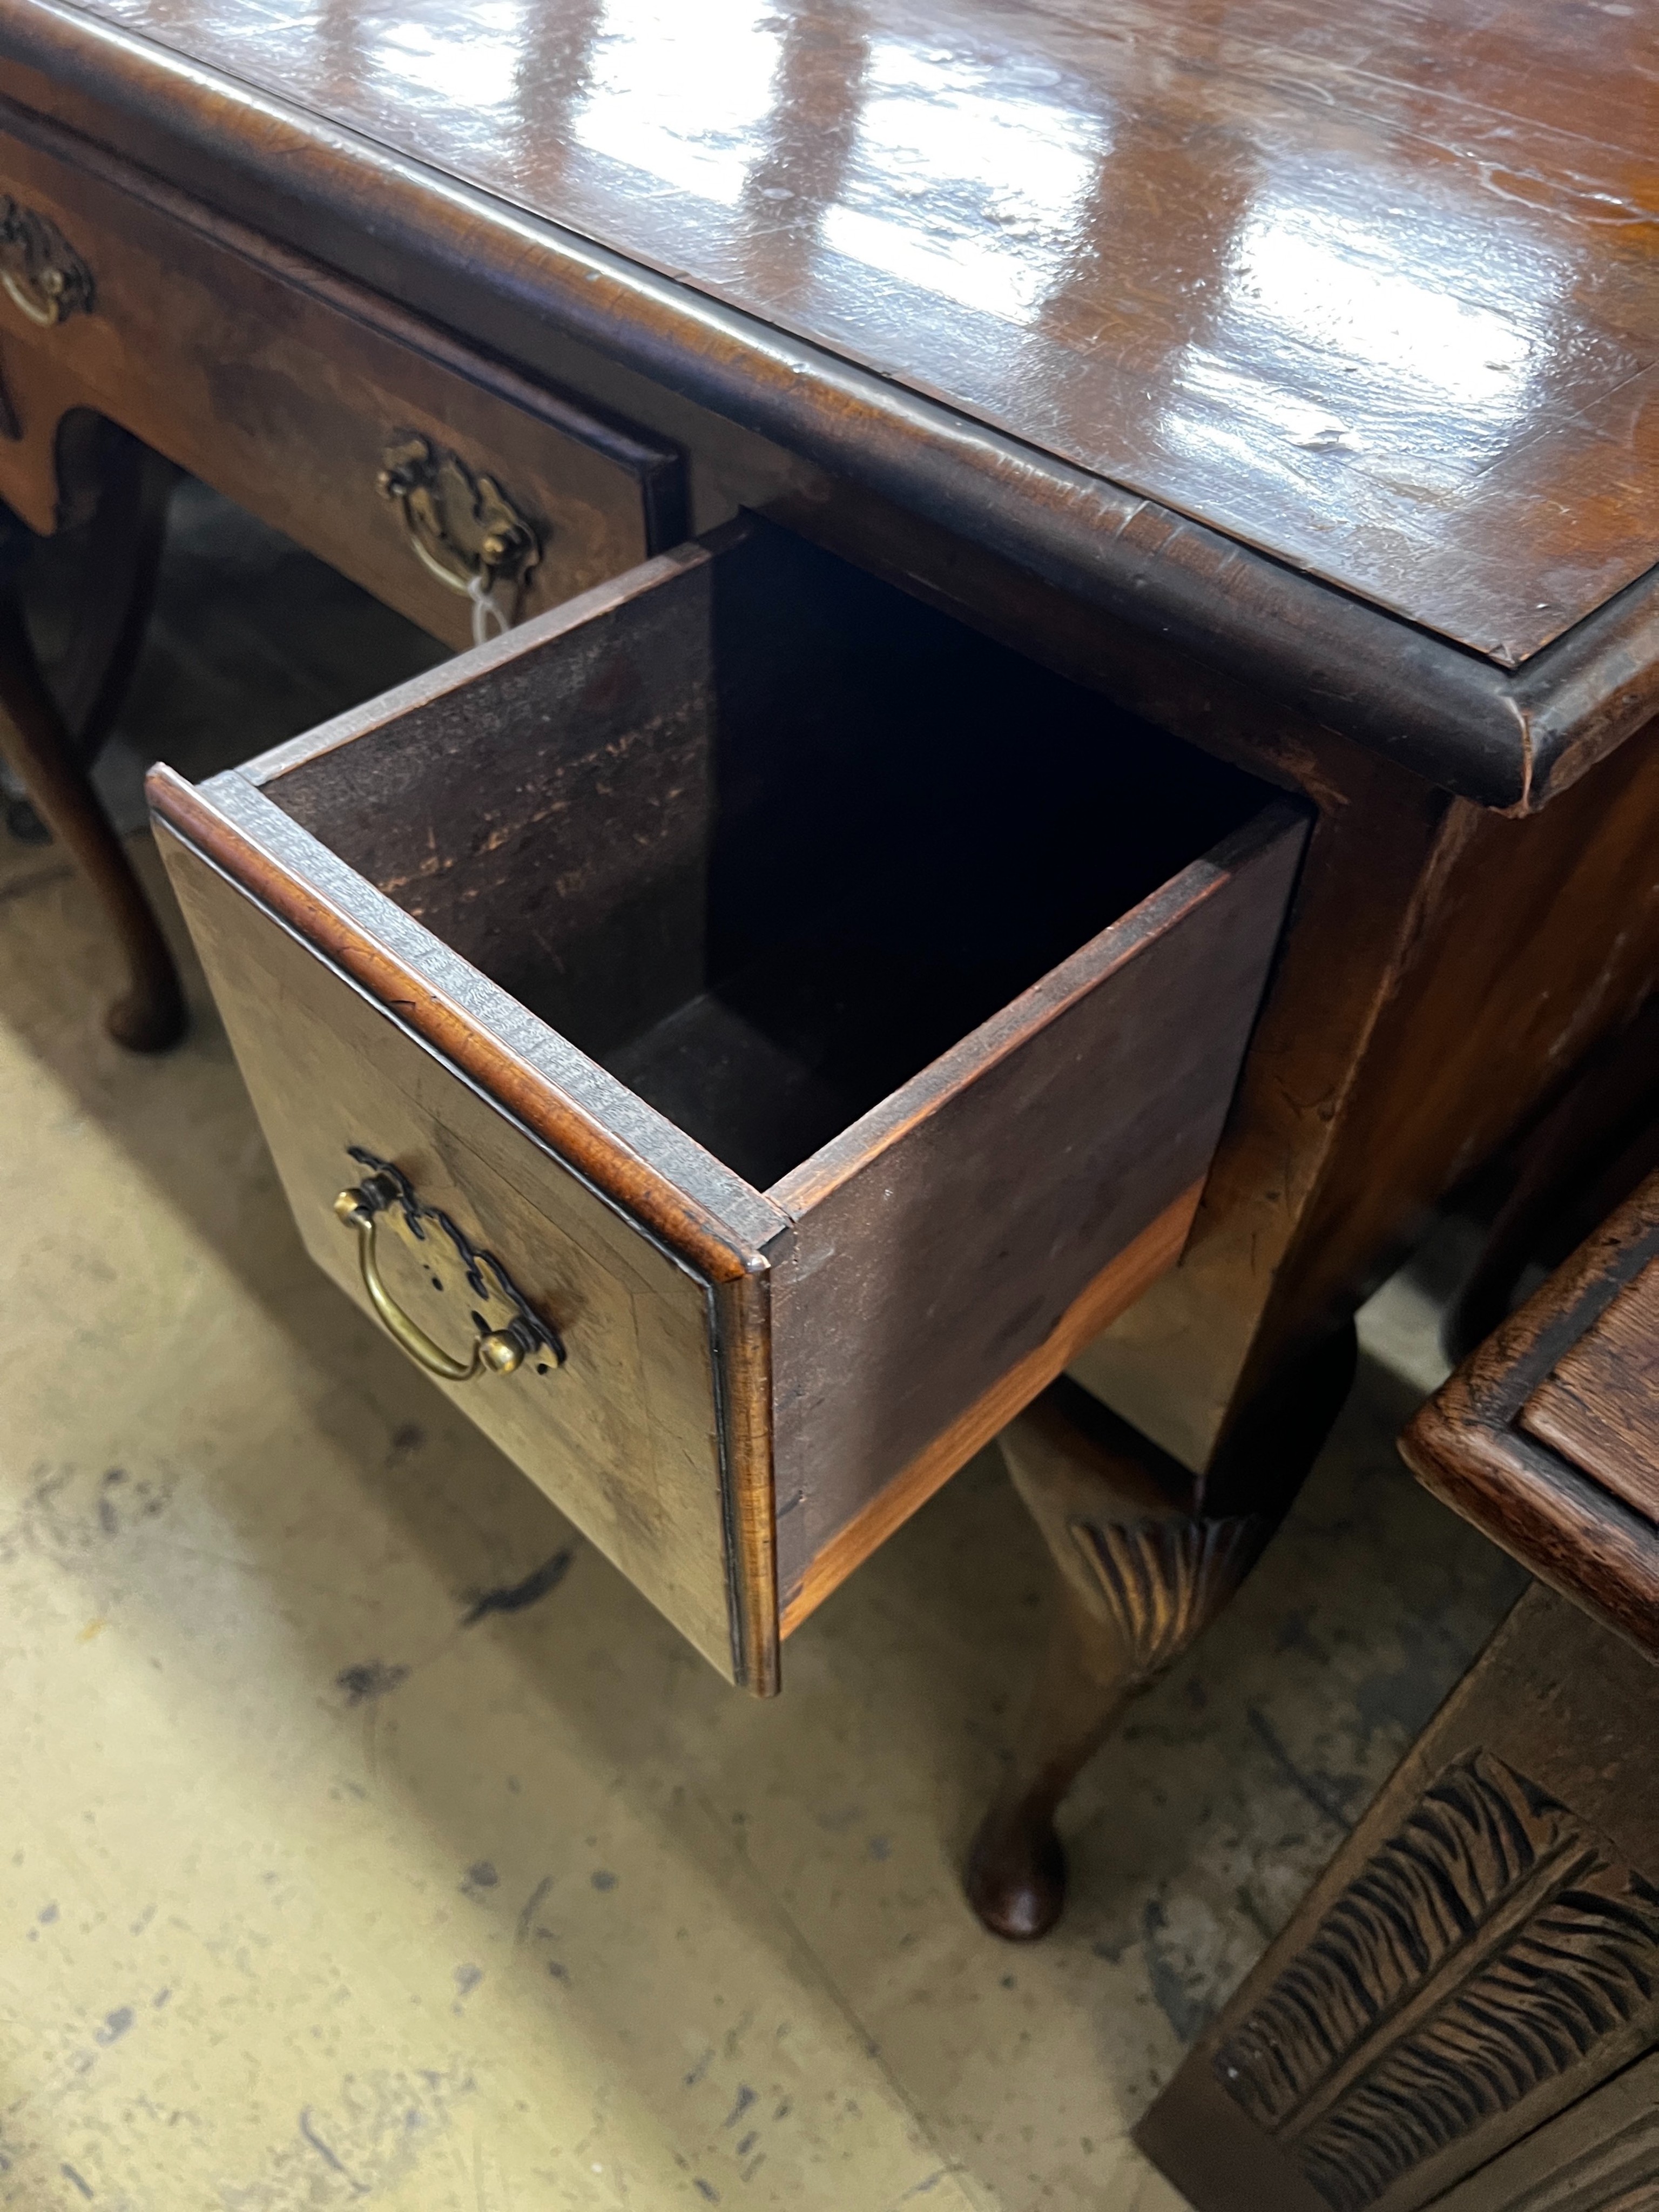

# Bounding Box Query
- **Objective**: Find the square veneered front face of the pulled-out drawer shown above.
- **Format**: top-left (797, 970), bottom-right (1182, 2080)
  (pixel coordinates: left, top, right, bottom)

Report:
top-left (164, 832), bottom-right (752, 1677)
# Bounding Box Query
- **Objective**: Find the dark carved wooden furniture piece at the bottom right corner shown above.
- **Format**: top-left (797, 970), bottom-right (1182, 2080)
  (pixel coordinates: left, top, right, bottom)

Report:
top-left (1139, 1175), bottom-right (1659, 2212)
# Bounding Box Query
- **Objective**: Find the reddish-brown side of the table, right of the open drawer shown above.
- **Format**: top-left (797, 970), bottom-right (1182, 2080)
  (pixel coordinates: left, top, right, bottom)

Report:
top-left (1077, 732), bottom-right (1659, 1511)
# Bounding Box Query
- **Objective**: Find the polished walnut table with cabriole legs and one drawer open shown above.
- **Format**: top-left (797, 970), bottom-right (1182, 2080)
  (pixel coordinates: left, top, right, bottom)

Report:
top-left (0, 0), bottom-right (1659, 1936)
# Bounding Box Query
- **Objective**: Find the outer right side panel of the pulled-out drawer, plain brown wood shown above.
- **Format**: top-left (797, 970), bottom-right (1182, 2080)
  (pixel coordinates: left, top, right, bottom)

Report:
top-left (772, 803), bottom-right (1305, 1621)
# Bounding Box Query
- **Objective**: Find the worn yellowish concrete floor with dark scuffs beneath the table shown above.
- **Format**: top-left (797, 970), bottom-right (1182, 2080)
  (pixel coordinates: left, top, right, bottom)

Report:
top-left (0, 493), bottom-right (1522, 2212)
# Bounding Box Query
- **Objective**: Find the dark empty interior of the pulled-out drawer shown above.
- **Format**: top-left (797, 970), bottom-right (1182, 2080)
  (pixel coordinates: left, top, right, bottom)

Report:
top-left (266, 520), bottom-right (1267, 1190)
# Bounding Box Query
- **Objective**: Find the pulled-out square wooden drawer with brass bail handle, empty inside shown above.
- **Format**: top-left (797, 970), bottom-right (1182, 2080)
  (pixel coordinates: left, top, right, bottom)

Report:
top-left (151, 520), bottom-right (1305, 1690)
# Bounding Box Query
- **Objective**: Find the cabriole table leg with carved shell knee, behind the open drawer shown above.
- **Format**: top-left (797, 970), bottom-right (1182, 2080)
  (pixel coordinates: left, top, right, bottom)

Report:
top-left (967, 1327), bottom-right (1354, 1942)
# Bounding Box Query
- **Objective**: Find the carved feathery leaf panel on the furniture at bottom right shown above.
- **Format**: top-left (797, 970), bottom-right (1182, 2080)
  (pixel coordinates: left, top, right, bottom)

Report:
top-left (1215, 1752), bottom-right (1659, 2212)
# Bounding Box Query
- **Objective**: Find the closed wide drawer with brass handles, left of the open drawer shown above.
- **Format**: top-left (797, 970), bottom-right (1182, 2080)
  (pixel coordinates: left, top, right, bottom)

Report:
top-left (0, 104), bottom-right (684, 646)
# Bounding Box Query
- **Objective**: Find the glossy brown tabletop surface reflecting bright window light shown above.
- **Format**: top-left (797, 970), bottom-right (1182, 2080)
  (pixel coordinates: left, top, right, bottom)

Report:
top-left (19, 0), bottom-right (1659, 666)
